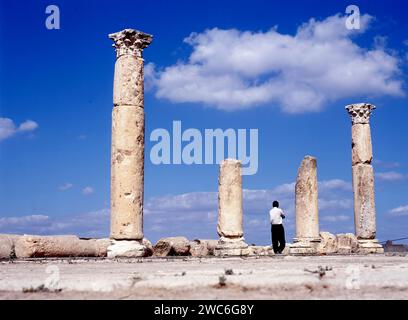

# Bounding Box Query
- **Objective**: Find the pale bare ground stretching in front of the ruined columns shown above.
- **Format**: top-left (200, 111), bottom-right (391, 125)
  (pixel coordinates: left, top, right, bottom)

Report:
top-left (0, 254), bottom-right (408, 300)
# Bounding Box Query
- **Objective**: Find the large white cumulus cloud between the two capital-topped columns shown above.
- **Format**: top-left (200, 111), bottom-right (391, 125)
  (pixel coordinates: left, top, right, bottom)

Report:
top-left (146, 14), bottom-right (404, 113)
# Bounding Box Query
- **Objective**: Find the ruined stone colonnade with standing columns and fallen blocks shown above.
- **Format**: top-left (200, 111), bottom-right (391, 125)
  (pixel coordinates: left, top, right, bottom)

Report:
top-left (0, 29), bottom-right (383, 259)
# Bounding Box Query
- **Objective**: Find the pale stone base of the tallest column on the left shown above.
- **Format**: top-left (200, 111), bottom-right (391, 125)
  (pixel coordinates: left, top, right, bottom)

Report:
top-left (107, 240), bottom-right (148, 259)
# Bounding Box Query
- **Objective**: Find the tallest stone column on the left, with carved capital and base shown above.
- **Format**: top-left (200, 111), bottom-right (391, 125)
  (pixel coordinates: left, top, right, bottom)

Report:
top-left (108, 29), bottom-right (152, 257)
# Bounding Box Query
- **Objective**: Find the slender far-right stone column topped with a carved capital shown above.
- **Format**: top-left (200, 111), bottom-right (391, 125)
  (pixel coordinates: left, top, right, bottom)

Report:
top-left (346, 103), bottom-right (384, 253)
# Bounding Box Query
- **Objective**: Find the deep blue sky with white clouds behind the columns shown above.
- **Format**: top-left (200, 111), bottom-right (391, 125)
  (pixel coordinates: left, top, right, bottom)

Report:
top-left (0, 0), bottom-right (408, 244)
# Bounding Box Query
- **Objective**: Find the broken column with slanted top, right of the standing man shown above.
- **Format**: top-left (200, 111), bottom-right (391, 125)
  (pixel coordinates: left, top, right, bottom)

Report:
top-left (290, 156), bottom-right (320, 254)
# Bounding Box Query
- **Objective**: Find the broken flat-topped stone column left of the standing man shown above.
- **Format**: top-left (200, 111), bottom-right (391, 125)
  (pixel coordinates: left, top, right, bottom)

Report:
top-left (214, 159), bottom-right (249, 256)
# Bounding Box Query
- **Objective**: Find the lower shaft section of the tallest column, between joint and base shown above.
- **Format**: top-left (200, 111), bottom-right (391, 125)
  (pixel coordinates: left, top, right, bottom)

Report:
top-left (111, 106), bottom-right (144, 240)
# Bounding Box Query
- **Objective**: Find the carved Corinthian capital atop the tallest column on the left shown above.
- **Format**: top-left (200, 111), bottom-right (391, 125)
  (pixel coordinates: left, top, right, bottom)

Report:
top-left (109, 29), bottom-right (153, 58)
